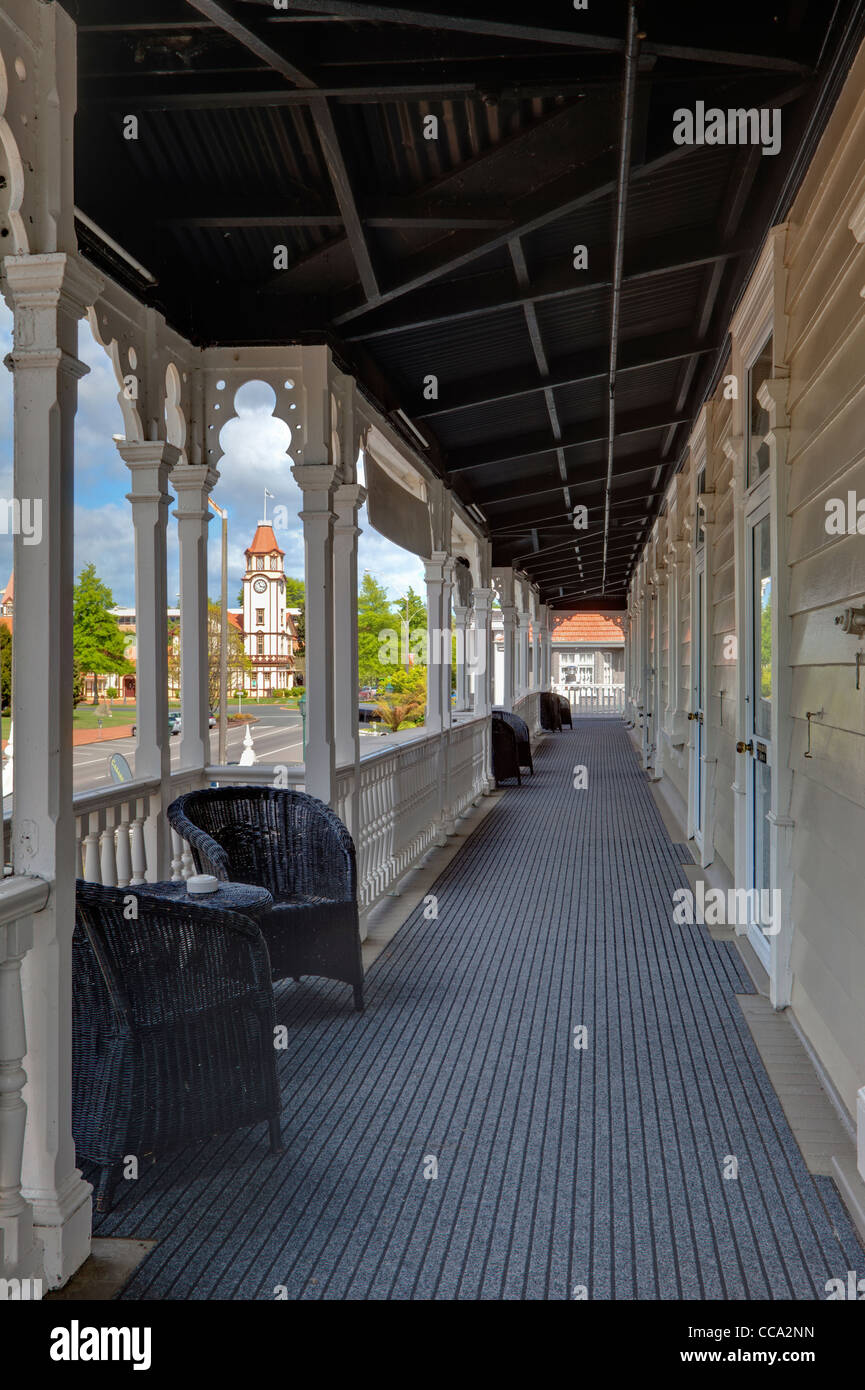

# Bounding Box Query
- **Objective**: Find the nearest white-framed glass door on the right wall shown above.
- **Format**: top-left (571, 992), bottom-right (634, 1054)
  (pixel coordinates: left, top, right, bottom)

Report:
top-left (744, 499), bottom-right (773, 969)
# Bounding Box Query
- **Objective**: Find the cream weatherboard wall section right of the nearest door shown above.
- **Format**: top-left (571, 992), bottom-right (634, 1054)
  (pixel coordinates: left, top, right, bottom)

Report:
top-left (786, 43), bottom-right (865, 1115)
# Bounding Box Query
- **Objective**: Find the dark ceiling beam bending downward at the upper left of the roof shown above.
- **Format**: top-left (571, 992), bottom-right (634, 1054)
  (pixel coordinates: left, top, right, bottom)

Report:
top-left (186, 0), bottom-right (380, 300)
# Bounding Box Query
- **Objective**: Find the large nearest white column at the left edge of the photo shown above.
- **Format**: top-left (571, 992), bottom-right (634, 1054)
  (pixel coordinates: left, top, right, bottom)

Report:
top-left (6, 253), bottom-right (100, 1287)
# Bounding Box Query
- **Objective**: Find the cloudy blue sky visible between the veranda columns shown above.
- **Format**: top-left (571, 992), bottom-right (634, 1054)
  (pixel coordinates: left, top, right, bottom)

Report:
top-left (0, 299), bottom-right (424, 607)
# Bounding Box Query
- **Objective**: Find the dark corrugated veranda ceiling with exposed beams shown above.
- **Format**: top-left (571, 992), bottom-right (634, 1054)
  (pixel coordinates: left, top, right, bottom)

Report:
top-left (65, 0), bottom-right (864, 607)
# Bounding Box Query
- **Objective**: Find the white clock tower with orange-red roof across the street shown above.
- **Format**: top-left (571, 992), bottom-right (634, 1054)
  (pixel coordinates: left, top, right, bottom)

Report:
top-left (243, 520), bottom-right (295, 695)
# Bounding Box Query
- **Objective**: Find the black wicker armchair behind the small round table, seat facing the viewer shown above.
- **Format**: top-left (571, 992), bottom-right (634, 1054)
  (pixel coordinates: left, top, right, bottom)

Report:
top-left (168, 787), bottom-right (363, 1009)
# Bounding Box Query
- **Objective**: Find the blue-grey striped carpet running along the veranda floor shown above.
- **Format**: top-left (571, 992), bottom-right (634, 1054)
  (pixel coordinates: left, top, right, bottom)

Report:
top-left (97, 720), bottom-right (865, 1300)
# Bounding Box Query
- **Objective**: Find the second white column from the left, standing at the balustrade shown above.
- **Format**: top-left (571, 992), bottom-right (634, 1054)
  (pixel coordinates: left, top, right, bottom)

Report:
top-left (117, 439), bottom-right (179, 881)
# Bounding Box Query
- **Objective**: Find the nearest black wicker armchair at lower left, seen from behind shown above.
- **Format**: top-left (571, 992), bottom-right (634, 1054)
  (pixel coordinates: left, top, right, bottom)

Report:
top-left (72, 881), bottom-right (282, 1211)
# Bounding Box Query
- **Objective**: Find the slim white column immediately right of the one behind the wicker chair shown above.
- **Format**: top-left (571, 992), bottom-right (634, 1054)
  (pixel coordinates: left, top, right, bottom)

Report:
top-left (334, 482), bottom-right (366, 835)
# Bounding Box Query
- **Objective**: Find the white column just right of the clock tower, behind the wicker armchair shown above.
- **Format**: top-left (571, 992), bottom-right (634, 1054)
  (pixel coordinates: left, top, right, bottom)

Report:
top-left (292, 463), bottom-right (340, 806)
